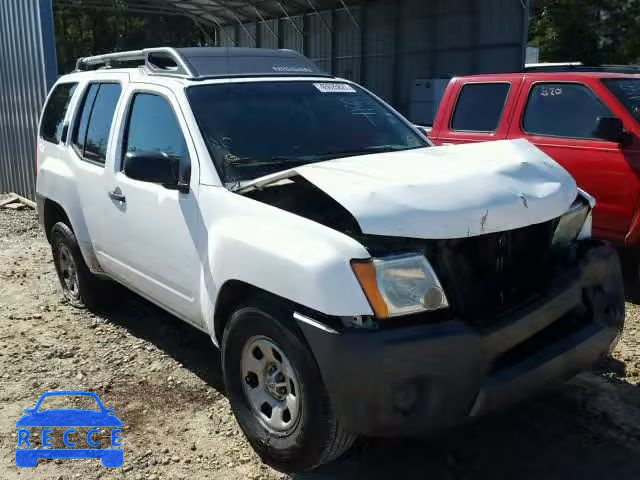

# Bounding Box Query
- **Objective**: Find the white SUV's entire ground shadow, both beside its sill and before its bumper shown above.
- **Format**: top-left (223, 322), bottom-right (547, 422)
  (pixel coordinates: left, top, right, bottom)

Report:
top-left (92, 288), bottom-right (640, 480)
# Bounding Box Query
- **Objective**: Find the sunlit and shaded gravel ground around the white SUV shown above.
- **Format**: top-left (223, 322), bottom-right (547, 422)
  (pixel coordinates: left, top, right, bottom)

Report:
top-left (0, 204), bottom-right (640, 480)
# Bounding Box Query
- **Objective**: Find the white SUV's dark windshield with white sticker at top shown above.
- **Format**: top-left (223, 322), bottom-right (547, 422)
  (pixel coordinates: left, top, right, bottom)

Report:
top-left (187, 81), bottom-right (429, 183)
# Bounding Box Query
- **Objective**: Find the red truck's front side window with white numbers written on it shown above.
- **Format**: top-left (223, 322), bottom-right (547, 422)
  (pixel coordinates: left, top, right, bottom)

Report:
top-left (522, 83), bottom-right (612, 139)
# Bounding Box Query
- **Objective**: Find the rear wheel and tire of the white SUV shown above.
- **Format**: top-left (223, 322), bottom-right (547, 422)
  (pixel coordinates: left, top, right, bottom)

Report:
top-left (51, 222), bottom-right (107, 309)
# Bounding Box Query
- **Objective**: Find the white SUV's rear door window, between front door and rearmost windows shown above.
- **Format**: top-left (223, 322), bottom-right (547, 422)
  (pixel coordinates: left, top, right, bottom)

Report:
top-left (72, 83), bottom-right (122, 165)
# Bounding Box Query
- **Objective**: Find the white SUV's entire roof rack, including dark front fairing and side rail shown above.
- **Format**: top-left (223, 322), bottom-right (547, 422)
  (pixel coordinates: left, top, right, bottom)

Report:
top-left (76, 47), bottom-right (331, 80)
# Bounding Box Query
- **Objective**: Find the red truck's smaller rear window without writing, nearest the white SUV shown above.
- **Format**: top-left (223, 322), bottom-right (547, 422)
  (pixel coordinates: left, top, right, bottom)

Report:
top-left (451, 83), bottom-right (510, 133)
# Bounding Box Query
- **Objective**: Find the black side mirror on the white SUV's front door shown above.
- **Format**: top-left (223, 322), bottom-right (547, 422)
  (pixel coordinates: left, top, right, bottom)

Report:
top-left (123, 152), bottom-right (189, 192)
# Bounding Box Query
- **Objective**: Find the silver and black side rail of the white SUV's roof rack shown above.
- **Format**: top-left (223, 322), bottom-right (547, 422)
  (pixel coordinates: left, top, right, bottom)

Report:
top-left (76, 47), bottom-right (197, 78)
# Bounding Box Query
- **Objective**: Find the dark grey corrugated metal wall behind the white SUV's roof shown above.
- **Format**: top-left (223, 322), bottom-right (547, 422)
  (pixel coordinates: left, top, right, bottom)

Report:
top-left (219, 0), bottom-right (529, 115)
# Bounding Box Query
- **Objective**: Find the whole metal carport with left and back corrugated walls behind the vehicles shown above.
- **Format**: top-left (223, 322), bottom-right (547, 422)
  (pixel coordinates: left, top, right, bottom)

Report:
top-left (0, 0), bottom-right (529, 198)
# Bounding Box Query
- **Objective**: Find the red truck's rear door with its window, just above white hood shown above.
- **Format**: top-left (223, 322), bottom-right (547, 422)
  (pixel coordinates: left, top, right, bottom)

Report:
top-left (434, 77), bottom-right (522, 145)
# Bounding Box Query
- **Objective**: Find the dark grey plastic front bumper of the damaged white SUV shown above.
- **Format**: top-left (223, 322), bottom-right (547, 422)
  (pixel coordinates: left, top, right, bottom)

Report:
top-left (299, 240), bottom-right (624, 436)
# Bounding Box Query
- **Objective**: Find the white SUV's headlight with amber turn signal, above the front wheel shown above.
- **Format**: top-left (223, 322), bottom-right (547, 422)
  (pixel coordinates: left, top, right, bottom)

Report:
top-left (351, 254), bottom-right (449, 318)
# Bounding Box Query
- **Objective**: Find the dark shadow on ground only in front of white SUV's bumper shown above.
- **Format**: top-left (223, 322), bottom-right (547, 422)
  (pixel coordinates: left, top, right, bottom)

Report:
top-left (293, 385), bottom-right (640, 480)
